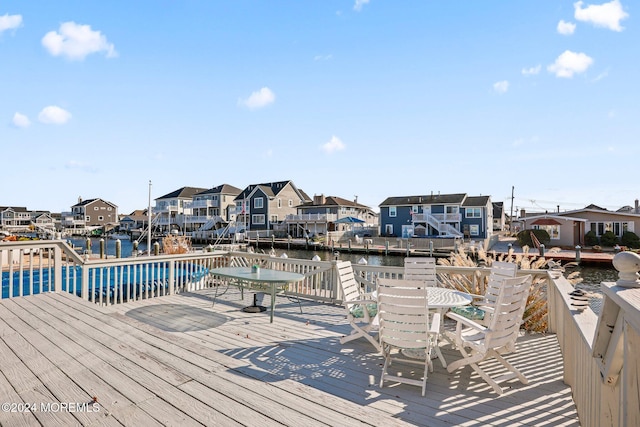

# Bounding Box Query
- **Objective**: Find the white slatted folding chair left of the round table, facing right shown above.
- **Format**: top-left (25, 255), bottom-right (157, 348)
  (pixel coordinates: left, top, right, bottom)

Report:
top-left (336, 261), bottom-right (380, 351)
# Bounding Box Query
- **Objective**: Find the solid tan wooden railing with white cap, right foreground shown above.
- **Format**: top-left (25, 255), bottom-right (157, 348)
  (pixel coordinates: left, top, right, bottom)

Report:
top-left (548, 252), bottom-right (640, 427)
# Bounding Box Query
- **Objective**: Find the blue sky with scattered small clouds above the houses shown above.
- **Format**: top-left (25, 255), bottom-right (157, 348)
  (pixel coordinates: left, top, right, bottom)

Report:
top-left (0, 0), bottom-right (640, 213)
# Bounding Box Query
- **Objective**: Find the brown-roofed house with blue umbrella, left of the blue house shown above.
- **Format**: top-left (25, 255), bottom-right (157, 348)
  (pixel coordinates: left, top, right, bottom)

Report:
top-left (285, 194), bottom-right (378, 240)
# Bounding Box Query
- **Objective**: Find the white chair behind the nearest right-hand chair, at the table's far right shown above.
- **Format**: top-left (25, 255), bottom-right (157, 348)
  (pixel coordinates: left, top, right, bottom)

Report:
top-left (451, 261), bottom-right (518, 326)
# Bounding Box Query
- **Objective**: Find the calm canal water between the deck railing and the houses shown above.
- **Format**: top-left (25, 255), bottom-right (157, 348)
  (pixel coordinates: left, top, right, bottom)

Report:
top-left (68, 238), bottom-right (618, 288)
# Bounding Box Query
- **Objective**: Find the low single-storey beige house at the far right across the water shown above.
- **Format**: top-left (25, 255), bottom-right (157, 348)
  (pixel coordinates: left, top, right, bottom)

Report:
top-left (520, 204), bottom-right (640, 247)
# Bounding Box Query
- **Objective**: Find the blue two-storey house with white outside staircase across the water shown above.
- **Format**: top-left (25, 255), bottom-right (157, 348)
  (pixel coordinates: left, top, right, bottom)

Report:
top-left (379, 193), bottom-right (493, 239)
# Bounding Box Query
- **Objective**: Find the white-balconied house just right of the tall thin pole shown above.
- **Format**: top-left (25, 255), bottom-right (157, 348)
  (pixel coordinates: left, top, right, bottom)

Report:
top-left (152, 187), bottom-right (206, 233)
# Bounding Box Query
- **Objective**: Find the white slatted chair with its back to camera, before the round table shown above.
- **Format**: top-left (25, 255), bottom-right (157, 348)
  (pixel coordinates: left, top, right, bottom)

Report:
top-left (377, 278), bottom-right (440, 396)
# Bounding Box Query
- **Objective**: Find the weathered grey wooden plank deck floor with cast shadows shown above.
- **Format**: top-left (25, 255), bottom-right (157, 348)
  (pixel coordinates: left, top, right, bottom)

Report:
top-left (0, 290), bottom-right (579, 427)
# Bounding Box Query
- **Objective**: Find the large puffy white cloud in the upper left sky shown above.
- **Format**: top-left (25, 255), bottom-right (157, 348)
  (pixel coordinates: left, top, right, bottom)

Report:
top-left (42, 22), bottom-right (118, 61)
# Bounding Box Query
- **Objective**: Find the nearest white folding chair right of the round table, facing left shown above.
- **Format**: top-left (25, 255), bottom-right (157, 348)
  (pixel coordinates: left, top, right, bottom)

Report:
top-left (446, 275), bottom-right (531, 394)
